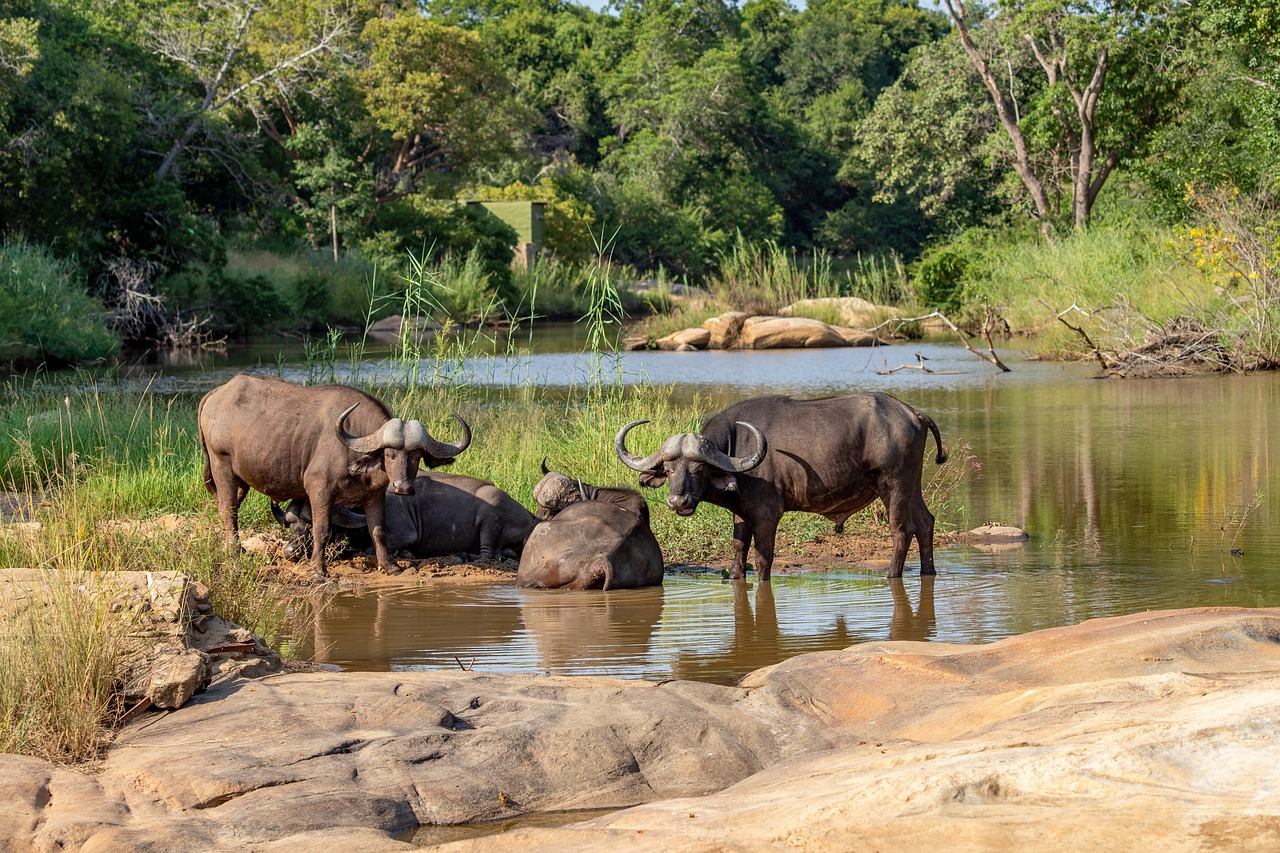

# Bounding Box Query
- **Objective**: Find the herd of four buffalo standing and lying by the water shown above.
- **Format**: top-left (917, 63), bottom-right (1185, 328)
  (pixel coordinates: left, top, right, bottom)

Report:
top-left (198, 374), bottom-right (947, 589)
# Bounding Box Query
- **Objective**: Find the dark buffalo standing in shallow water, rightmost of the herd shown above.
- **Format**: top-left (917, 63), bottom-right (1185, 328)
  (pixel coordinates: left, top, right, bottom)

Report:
top-left (613, 392), bottom-right (947, 580)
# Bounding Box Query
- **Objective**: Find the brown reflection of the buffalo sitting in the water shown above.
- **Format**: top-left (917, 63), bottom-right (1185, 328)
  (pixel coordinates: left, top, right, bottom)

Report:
top-left (520, 587), bottom-right (663, 672)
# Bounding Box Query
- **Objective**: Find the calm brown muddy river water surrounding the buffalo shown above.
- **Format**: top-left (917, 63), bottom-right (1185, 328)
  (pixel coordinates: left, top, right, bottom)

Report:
top-left (277, 343), bottom-right (1280, 684)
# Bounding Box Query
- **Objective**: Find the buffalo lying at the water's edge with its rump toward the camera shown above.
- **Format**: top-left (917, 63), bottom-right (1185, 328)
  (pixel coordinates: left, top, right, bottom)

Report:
top-left (516, 460), bottom-right (663, 589)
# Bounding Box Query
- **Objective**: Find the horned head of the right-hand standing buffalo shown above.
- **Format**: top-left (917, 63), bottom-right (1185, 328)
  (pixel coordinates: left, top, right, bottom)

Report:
top-left (613, 420), bottom-right (769, 515)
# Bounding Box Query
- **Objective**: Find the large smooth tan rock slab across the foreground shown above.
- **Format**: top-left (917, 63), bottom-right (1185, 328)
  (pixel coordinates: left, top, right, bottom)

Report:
top-left (0, 608), bottom-right (1280, 853)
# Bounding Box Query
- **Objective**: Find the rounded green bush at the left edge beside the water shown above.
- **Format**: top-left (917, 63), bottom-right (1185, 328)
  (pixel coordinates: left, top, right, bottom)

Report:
top-left (0, 241), bottom-right (119, 365)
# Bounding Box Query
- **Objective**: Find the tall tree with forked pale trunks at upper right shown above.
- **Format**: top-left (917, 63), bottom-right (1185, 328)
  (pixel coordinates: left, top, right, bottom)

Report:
top-left (942, 0), bottom-right (1184, 233)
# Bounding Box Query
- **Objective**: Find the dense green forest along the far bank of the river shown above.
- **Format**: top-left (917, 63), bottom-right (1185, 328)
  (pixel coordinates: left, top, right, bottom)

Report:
top-left (0, 0), bottom-right (1280, 360)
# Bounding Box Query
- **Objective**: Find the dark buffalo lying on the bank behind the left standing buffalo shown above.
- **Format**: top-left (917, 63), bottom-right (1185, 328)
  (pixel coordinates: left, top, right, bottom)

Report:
top-left (271, 471), bottom-right (538, 560)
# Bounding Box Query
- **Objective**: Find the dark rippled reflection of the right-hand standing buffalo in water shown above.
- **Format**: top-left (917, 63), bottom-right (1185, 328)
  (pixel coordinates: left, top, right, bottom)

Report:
top-left (672, 575), bottom-right (937, 684)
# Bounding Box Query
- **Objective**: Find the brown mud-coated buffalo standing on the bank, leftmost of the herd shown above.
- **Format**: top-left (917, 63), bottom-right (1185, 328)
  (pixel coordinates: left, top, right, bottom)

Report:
top-left (197, 374), bottom-right (471, 575)
